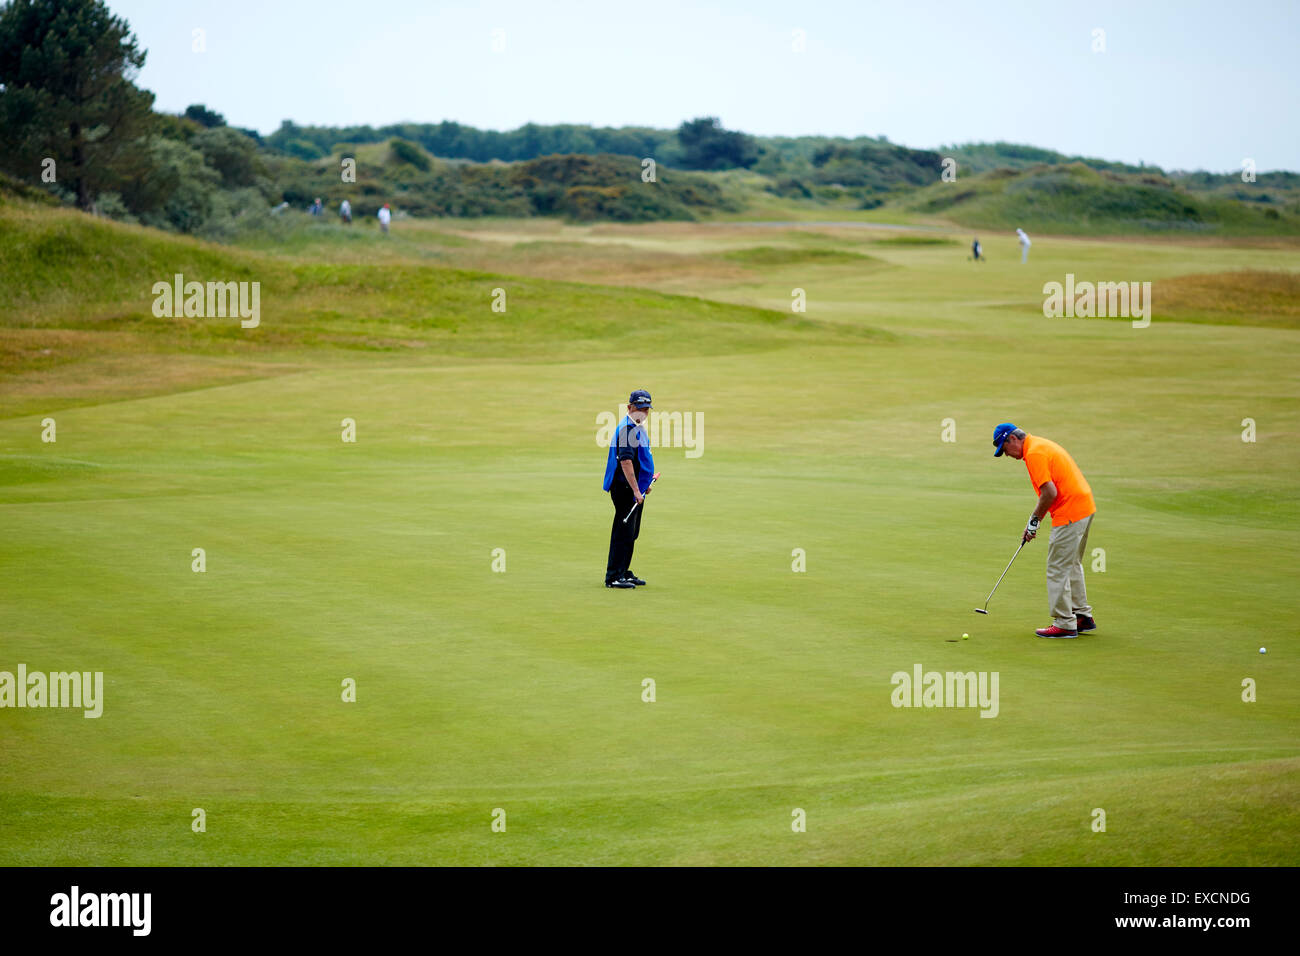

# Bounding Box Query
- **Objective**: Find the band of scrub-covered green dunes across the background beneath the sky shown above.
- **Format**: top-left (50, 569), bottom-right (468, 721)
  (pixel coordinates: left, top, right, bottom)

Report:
top-left (9, 114), bottom-right (1300, 242)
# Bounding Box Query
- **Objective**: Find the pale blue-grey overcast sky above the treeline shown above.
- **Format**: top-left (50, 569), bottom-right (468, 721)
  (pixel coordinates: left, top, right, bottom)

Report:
top-left (108, 0), bottom-right (1300, 172)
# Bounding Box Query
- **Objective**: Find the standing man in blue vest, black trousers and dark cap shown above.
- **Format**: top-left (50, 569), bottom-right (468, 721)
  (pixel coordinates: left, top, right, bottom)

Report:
top-left (605, 389), bottom-right (654, 588)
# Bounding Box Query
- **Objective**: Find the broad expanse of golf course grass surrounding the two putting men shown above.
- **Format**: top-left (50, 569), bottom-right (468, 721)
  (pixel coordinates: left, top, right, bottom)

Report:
top-left (0, 218), bottom-right (1300, 866)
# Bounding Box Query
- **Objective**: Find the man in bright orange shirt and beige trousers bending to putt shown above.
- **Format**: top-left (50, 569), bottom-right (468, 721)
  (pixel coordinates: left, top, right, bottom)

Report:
top-left (993, 421), bottom-right (1097, 637)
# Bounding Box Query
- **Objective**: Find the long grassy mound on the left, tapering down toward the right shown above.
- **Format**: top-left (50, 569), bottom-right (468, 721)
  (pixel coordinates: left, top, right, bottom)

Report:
top-left (0, 193), bottom-right (863, 412)
